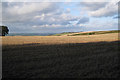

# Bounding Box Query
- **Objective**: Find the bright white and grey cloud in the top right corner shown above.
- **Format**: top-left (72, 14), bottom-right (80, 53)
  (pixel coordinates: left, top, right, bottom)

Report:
top-left (81, 0), bottom-right (119, 17)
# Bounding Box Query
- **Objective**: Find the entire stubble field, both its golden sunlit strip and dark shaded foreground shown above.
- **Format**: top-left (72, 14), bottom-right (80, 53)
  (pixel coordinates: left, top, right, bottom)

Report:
top-left (2, 33), bottom-right (120, 79)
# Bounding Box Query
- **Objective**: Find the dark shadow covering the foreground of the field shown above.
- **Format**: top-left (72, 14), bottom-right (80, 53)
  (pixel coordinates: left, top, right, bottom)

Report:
top-left (2, 41), bottom-right (120, 79)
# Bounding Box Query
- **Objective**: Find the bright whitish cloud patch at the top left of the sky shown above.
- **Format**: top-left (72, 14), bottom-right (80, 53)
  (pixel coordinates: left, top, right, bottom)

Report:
top-left (6, 3), bottom-right (52, 15)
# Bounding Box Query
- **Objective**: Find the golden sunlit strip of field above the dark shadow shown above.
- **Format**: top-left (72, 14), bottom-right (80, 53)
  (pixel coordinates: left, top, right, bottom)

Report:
top-left (2, 33), bottom-right (118, 45)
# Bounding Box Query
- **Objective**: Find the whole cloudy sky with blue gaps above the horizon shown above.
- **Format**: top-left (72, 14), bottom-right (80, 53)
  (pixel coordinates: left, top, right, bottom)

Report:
top-left (0, 0), bottom-right (119, 33)
